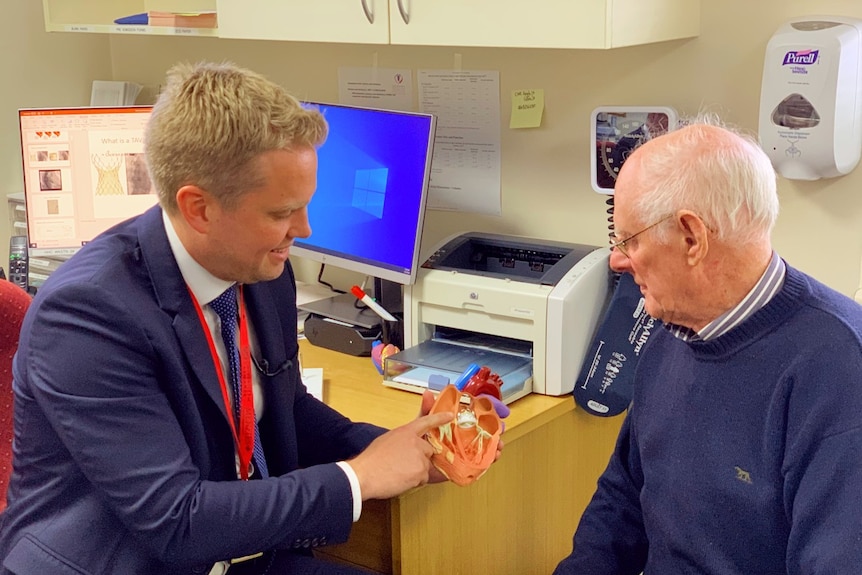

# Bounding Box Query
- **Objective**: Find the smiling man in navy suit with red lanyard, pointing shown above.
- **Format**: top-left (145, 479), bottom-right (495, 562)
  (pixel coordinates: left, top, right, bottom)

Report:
top-left (0, 64), bottom-right (452, 575)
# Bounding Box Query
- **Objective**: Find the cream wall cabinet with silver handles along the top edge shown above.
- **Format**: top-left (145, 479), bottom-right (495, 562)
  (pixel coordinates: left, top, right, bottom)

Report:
top-left (43, 0), bottom-right (700, 49)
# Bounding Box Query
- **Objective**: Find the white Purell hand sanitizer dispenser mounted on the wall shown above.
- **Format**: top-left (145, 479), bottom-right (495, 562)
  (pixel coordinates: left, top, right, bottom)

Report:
top-left (760, 16), bottom-right (862, 180)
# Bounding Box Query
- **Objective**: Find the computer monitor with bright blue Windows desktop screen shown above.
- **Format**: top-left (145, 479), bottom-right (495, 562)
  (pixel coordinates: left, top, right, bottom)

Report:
top-left (291, 102), bottom-right (436, 284)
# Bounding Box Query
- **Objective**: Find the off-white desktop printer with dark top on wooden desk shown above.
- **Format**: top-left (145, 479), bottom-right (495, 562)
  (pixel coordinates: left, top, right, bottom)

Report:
top-left (383, 232), bottom-right (612, 403)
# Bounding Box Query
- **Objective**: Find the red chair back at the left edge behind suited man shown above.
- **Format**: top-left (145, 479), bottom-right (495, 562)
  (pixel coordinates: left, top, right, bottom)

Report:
top-left (0, 280), bottom-right (30, 511)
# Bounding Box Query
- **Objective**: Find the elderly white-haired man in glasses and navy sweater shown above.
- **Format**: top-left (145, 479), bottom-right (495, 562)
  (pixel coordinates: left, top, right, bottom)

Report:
top-left (555, 121), bottom-right (862, 575)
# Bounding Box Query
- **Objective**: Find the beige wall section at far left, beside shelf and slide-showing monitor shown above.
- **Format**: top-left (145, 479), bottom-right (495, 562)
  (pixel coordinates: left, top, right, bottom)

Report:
top-left (0, 0), bottom-right (111, 269)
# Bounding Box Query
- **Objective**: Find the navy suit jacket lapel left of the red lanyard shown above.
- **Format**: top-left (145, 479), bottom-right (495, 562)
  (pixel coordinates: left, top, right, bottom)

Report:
top-left (138, 206), bottom-right (228, 419)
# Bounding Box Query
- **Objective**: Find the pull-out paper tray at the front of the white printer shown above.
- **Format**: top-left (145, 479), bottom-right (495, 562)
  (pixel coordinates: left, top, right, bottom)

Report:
top-left (383, 340), bottom-right (533, 403)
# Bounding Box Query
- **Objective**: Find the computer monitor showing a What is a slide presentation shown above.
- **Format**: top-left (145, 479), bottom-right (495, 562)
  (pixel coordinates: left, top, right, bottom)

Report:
top-left (18, 106), bottom-right (158, 256)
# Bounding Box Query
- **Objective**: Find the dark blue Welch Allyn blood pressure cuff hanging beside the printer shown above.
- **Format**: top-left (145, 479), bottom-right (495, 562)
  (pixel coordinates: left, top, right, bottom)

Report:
top-left (574, 274), bottom-right (660, 417)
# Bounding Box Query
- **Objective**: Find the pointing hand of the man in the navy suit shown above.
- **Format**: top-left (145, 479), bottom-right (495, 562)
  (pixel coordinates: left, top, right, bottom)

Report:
top-left (347, 412), bottom-right (455, 501)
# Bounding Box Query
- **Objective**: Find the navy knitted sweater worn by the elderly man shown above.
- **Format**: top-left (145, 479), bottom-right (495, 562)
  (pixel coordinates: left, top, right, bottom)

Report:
top-left (555, 266), bottom-right (862, 575)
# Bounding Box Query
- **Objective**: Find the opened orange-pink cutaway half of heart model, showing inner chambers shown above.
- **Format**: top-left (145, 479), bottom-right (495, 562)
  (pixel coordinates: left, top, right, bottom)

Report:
top-left (426, 385), bottom-right (503, 486)
